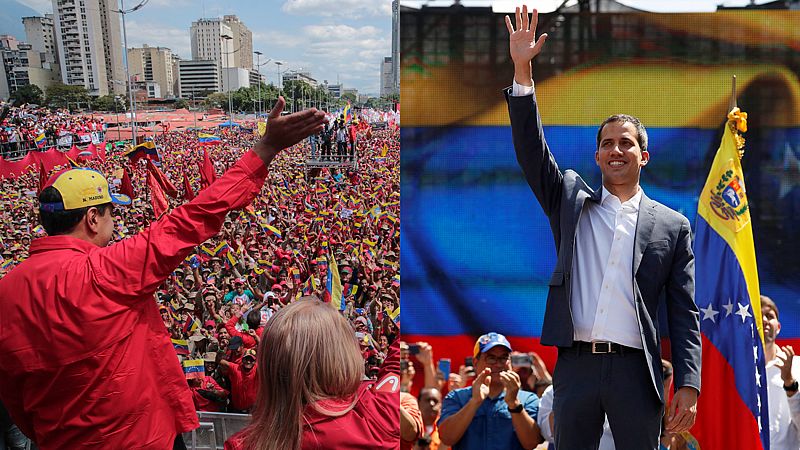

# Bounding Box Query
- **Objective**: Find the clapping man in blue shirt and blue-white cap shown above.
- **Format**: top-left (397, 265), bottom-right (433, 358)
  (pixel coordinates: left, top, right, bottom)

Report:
top-left (438, 332), bottom-right (542, 450)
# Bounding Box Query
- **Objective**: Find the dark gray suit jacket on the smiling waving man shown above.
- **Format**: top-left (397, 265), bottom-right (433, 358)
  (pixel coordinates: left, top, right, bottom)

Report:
top-left (505, 88), bottom-right (701, 401)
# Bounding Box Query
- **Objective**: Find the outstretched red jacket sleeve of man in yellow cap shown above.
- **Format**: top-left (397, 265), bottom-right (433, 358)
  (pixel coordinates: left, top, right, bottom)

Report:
top-left (90, 151), bottom-right (268, 301)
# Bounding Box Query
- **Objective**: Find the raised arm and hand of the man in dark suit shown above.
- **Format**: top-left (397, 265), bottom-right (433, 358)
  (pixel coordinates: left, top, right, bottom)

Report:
top-left (505, 6), bottom-right (564, 216)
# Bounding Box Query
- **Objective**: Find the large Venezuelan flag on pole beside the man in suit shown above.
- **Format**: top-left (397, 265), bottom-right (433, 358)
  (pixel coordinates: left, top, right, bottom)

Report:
top-left (692, 108), bottom-right (769, 450)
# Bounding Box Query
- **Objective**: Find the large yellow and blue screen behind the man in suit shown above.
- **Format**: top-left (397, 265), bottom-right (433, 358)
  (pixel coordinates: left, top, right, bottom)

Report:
top-left (401, 6), bottom-right (800, 364)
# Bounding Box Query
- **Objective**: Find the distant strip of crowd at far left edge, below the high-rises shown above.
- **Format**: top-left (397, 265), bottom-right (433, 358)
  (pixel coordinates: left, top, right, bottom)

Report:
top-left (0, 102), bottom-right (104, 158)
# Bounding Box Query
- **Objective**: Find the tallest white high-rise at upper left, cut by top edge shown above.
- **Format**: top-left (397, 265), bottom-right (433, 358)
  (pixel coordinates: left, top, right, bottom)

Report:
top-left (53, 0), bottom-right (126, 95)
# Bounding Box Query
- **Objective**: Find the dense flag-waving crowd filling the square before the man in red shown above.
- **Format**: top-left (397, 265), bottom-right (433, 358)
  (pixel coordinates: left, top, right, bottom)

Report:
top-left (0, 100), bottom-right (400, 448)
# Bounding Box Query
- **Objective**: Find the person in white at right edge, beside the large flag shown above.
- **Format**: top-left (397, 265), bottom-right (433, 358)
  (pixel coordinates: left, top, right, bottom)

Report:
top-left (761, 295), bottom-right (800, 450)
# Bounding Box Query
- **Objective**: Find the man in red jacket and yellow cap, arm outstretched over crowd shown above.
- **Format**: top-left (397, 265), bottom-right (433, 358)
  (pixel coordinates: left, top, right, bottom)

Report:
top-left (0, 98), bottom-right (324, 450)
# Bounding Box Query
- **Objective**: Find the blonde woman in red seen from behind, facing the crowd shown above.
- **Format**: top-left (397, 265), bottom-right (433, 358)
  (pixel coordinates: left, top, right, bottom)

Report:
top-left (225, 297), bottom-right (400, 450)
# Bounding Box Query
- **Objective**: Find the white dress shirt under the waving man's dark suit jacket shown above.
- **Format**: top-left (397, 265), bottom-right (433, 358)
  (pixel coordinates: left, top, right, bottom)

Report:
top-left (511, 80), bottom-right (644, 348)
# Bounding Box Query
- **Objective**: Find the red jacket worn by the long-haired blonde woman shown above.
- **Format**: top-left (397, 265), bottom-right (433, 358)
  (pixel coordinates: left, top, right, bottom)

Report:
top-left (225, 340), bottom-right (400, 450)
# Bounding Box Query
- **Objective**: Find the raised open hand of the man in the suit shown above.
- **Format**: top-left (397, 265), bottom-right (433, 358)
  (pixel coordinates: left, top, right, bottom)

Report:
top-left (506, 5), bottom-right (547, 86)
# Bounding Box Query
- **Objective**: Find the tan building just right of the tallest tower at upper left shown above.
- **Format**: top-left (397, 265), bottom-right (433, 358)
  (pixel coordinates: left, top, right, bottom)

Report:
top-left (128, 44), bottom-right (175, 98)
